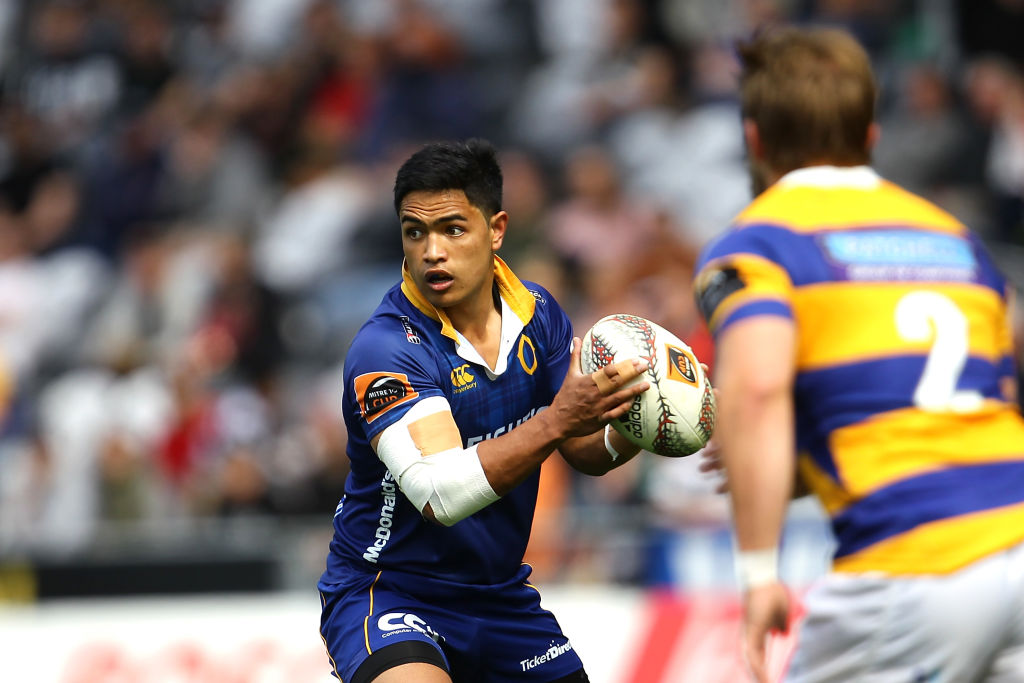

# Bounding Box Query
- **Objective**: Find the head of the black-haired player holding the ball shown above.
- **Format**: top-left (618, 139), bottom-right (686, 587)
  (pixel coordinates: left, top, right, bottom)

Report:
top-left (394, 139), bottom-right (508, 315)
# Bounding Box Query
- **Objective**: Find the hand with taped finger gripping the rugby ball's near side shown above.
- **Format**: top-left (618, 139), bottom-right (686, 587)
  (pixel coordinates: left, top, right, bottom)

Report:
top-left (548, 337), bottom-right (650, 436)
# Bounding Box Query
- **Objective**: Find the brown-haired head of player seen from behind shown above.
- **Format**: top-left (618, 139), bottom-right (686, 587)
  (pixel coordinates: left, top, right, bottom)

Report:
top-left (737, 28), bottom-right (877, 193)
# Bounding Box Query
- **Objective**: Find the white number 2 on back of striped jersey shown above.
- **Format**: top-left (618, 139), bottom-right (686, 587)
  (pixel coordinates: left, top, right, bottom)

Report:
top-left (896, 291), bottom-right (982, 413)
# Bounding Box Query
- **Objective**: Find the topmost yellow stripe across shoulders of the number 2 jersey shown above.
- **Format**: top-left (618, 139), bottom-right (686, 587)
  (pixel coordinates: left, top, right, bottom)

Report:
top-left (735, 180), bottom-right (965, 233)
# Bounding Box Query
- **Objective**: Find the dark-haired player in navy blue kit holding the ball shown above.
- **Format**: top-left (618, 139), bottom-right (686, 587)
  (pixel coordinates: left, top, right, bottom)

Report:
top-left (318, 140), bottom-right (648, 683)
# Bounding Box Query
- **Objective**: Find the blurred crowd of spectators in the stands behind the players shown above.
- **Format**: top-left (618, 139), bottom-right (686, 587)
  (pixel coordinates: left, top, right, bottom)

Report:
top-left (0, 0), bottom-right (1024, 589)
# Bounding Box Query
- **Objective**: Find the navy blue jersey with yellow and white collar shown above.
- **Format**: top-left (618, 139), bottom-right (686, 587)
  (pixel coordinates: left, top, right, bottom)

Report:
top-left (319, 257), bottom-right (572, 592)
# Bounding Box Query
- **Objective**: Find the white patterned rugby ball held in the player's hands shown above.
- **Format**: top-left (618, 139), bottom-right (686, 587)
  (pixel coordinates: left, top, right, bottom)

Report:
top-left (580, 313), bottom-right (715, 458)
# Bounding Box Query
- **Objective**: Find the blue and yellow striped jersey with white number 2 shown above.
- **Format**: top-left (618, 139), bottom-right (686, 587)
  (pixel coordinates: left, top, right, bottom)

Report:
top-left (696, 167), bottom-right (1024, 574)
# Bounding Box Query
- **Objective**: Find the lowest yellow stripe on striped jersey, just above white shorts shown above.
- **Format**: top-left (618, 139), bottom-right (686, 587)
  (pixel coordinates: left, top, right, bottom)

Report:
top-left (833, 503), bottom-right (1024, 575)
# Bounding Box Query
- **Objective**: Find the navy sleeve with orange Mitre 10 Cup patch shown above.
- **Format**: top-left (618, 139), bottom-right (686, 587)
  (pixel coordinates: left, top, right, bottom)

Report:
top-left (345, 318), bottom-right (444, 440)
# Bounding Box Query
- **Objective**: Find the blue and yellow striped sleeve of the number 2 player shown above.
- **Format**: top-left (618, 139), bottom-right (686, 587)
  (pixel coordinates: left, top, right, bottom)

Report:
top-left (694, 226), bottom-right (793, 336)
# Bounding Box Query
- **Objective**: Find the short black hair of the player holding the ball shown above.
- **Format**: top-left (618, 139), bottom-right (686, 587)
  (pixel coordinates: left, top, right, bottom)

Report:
top-left (394, 138), bottom-right (503, 218)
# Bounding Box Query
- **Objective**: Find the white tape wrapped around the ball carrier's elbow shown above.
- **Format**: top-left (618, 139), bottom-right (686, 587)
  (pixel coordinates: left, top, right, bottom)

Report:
top-left (377, 396), bottom-right (499, 526)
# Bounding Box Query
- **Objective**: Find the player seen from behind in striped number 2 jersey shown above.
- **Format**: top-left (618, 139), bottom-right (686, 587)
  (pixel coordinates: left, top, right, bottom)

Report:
top-left (695, 28), bottom-right (1024, 683)
